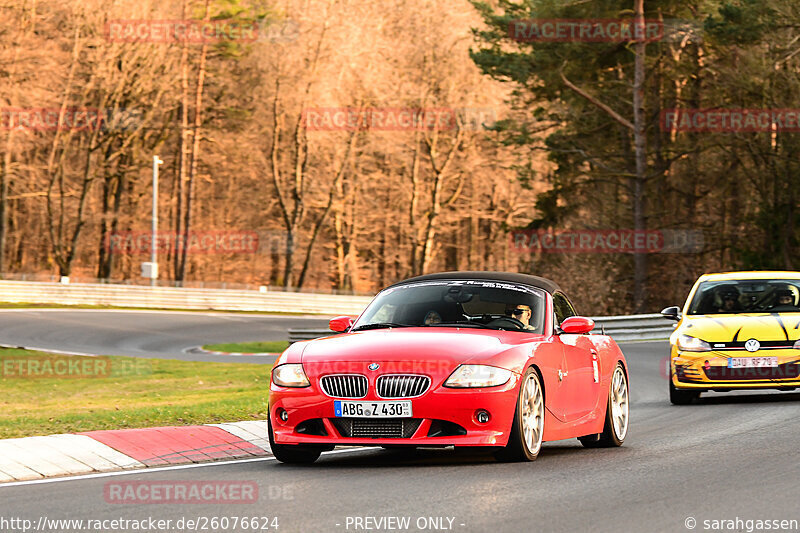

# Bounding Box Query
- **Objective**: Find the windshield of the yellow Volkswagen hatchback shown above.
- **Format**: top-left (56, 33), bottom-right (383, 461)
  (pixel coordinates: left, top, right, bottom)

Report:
top-left (688, 279), bottom-right (800, 315)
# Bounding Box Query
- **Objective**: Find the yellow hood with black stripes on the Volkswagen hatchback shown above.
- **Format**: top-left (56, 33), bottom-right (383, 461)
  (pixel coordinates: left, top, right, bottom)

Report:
top-left (675, 313), bottom-right (800, 343)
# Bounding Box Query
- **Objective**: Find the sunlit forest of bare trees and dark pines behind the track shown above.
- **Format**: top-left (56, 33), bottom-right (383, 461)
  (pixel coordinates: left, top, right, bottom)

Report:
top-left (0, 0), bottom-right (800, 315)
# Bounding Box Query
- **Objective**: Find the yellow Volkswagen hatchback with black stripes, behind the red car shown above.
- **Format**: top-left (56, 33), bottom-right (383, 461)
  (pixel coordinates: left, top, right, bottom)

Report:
top-left (661, 272), bottom-right (800, 405)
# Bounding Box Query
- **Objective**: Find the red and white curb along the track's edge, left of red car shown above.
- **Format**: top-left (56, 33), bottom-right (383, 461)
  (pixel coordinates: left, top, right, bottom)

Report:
top-left (0, 420), bottom-right (272, 483)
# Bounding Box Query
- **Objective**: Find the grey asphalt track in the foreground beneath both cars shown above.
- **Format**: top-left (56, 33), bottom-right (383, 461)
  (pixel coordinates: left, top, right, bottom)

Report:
top-left (0, 326), bottom-right (800, 533)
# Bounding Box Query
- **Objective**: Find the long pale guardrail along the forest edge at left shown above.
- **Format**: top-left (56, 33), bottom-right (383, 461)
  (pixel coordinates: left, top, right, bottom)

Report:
top-left (0, 280), bottom-right (372, 315)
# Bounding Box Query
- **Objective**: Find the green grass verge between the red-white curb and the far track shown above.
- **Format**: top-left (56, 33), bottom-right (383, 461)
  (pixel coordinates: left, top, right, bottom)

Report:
top-left (0, 348), bottom-right (271, 439)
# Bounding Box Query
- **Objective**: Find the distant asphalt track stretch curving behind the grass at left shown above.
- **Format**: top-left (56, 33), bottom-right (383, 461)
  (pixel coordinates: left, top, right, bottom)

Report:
top-left (0, 309), bottom-right (328, 363)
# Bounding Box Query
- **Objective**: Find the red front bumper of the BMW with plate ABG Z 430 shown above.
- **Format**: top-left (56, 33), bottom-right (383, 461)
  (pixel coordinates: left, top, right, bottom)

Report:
top-left (269, 374), bottom-right (519, 446)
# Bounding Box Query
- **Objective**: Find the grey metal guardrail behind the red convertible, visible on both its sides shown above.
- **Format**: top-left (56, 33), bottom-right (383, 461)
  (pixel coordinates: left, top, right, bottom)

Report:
top-left (289, 314), bottom-right (675, 343)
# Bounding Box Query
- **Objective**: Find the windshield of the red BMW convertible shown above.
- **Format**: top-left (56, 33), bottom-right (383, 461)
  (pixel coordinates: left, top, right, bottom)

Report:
top-left (353, 280), bottom-right (545, 334)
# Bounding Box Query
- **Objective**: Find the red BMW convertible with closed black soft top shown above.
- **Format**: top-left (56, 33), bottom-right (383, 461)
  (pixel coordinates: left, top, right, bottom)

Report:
top-left (268, 272), bottom-right (629, 463)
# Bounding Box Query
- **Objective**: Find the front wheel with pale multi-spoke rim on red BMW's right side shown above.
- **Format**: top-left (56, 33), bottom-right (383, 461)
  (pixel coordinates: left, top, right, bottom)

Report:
top-left (494, 368), bottom-right (544, 462)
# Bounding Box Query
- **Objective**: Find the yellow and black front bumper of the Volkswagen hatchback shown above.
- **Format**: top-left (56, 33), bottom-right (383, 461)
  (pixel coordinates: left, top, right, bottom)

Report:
top-left (670, 347), bottom-right (800, 390)
